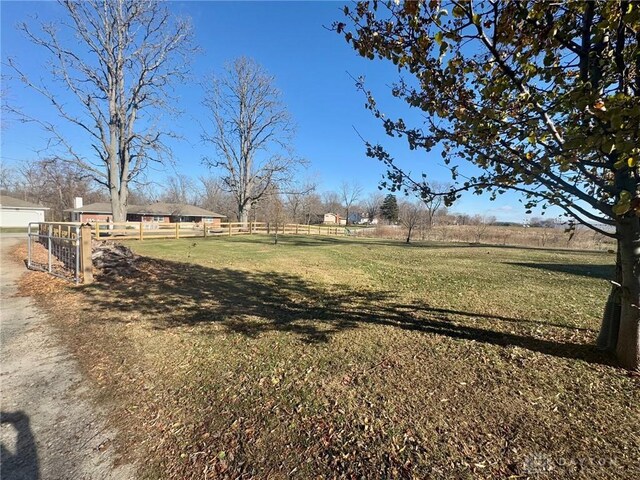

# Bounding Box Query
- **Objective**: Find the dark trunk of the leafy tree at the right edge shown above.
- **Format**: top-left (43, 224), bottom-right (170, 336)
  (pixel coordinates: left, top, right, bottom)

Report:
top-left (616, 216), bottom-right (640, 370)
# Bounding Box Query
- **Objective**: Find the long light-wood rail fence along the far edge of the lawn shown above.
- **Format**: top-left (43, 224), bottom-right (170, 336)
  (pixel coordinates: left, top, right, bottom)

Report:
top-left (92, 222), bottom-right (350, 240)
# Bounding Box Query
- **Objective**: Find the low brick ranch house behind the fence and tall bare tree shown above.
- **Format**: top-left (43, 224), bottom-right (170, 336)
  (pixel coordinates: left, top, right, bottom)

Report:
top-left (65, 199), bottom-right (226, 227)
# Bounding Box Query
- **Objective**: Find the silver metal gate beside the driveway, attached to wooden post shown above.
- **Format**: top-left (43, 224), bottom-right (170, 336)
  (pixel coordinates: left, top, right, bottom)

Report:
top-left (27, 222), bottom-right (81, 283)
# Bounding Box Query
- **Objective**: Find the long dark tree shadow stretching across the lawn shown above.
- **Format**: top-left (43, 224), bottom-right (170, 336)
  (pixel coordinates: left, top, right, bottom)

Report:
top-left (80, 257), bottom-right (610, 364)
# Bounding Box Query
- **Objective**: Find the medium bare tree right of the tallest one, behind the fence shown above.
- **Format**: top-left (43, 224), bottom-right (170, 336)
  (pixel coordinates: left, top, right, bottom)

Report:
top-left (202, 57), bottom-right (304, 224)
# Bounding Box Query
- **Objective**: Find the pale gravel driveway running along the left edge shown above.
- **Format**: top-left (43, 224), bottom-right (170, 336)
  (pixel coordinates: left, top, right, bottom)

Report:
top-left (0, 235), bottom-right (136, 480)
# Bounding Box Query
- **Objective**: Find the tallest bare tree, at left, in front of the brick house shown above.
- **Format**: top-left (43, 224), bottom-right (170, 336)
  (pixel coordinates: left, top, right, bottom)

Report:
top-left (8, 0), bottom-right (194, 221)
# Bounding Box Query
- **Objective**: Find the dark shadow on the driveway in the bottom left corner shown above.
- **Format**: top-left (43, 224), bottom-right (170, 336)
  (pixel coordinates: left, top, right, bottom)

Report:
top-left (0, 411), bottom-right (40, 480)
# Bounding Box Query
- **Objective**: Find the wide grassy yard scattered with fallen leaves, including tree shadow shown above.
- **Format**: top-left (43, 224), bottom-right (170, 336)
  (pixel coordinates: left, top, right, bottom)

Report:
top-left (21, 236), bottom-right (640, 479)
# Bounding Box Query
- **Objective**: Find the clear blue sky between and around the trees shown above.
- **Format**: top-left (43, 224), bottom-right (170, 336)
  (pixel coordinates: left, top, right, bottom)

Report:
top-left (1, 0), bottom-right (556, 221)
